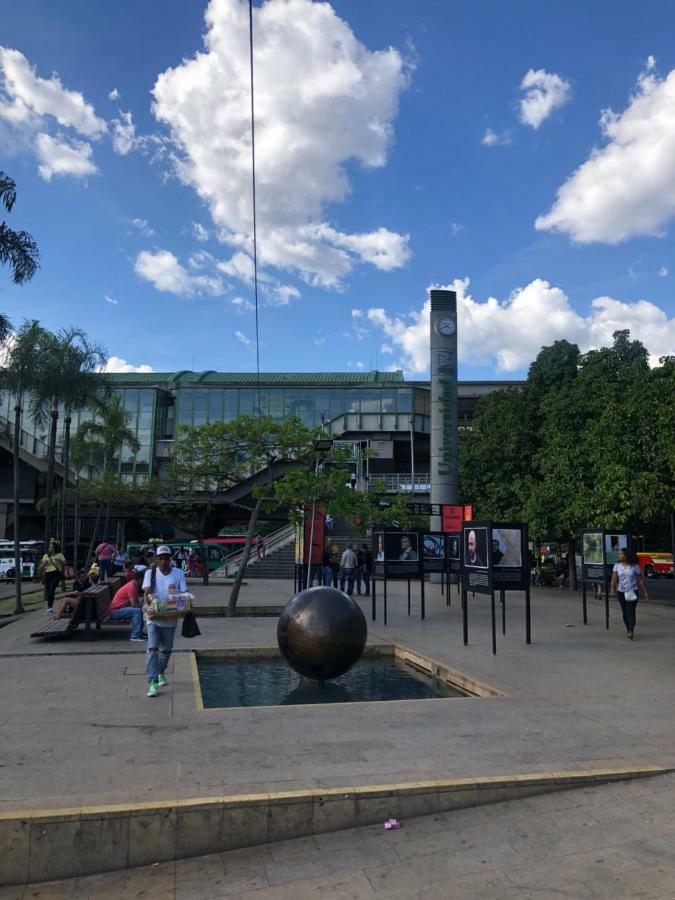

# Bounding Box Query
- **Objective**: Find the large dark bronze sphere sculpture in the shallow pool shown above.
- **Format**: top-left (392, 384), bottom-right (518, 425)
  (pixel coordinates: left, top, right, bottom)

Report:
top-left (277, 587), bottom-right (368, 681)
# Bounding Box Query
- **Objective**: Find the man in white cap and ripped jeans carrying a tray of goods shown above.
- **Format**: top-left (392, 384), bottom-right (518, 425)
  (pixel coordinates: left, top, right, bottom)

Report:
top-left (143, 544), bottom-right (187, 697)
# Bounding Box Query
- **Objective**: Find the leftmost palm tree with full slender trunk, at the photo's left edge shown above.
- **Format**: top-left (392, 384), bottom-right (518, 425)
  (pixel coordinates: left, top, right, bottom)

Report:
top-left (0, 319), bottom-right (51, 614)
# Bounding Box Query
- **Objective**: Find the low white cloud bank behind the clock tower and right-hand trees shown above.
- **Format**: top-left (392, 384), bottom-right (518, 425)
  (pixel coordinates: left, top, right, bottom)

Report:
top-left (367, 278), bottom-right (675, 374)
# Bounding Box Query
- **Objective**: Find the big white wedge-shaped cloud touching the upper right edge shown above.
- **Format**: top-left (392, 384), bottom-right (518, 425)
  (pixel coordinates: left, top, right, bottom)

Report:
top-left (535, 65), bottom-right (675, 244)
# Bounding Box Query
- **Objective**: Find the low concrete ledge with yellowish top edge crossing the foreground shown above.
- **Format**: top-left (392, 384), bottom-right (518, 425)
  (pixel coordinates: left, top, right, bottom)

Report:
top-left (0, 766), bottom-right (667, 885)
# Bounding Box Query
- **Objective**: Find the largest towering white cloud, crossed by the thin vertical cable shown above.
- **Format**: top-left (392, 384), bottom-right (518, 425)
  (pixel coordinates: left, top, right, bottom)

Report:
top-left (153, 0), bottom-right (409, 287)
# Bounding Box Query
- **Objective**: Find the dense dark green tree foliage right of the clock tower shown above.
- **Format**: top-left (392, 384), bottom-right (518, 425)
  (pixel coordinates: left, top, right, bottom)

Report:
top-left (460, 331), bottom-right (675, 541)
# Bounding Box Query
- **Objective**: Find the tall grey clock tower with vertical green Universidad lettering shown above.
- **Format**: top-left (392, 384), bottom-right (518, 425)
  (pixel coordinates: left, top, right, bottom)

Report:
top-left (430, 290), bottom-right (457, 531)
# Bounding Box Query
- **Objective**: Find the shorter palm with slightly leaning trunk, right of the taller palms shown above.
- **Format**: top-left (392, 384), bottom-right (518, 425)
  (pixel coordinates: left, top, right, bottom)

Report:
top-left (77, 395), bottom-right (141, 562)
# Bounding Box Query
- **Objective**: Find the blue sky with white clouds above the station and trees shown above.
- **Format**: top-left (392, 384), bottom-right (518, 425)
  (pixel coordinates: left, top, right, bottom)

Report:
top-left (0, 0), bottom-right (675, 378)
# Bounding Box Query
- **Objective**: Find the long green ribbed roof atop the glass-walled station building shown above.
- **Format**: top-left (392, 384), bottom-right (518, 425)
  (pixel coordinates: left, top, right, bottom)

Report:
top-left (102, 370), bottom-right (403, 387)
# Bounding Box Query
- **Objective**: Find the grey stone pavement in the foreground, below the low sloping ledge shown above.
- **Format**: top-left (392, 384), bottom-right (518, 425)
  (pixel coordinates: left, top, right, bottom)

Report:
top-left (6, 774), bottom-right (675, 900)
